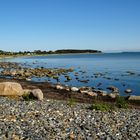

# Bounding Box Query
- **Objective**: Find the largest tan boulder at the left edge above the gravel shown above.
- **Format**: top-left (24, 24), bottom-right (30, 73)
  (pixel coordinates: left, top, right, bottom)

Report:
top-left (0, 82), bottom-right (23, 96)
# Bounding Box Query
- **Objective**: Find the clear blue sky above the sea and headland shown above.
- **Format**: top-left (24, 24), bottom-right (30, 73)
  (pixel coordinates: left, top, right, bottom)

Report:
top-left (0, 0), bottom-right (140, 52)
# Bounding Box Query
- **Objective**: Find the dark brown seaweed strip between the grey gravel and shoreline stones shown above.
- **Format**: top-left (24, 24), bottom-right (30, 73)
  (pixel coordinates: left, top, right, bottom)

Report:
top-left (0, 78), bottom-right (140, 109)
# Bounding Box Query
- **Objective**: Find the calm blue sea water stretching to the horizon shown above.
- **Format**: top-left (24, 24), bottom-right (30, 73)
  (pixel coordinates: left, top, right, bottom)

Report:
top-left (1, 53), bottom-right (140, 95)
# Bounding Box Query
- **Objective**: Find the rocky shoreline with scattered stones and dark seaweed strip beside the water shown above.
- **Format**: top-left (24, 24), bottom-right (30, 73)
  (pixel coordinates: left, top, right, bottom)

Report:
top-left (0, 56), bottom-right (140, 106)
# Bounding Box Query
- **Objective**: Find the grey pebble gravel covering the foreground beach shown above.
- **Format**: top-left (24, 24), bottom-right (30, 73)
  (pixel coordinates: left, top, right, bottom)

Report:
top-left (0, 97), bottom-right (140, 140)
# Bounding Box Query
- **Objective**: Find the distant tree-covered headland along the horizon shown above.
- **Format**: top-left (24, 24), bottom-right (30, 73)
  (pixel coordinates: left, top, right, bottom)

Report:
top-left (0, 49), bottom-right (102, 56)
